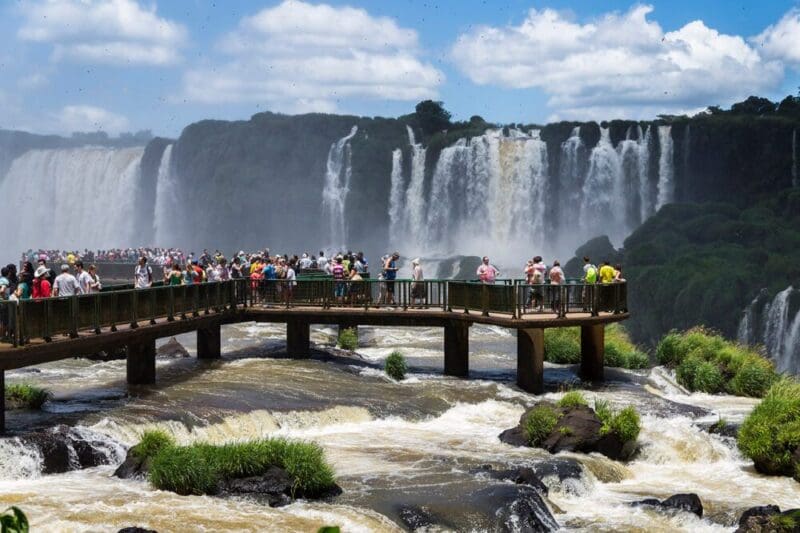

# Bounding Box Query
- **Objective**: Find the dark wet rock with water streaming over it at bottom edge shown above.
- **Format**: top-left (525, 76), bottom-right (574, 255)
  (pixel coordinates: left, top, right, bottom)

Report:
top-left (474, 485), bottom-right (559, 533)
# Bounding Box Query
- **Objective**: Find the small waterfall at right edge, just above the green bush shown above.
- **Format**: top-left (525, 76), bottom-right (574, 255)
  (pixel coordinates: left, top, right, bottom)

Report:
top-left (738, 287), bottom-right (800, 374)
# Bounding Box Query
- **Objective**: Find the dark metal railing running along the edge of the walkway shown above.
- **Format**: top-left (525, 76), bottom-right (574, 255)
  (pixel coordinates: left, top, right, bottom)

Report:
top-left (0, 278), bottom-right (627, 346)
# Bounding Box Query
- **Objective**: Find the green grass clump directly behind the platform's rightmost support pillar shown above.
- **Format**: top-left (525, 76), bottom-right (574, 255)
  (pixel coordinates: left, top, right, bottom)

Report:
top-left (544, 324), bottom-right (650, 368)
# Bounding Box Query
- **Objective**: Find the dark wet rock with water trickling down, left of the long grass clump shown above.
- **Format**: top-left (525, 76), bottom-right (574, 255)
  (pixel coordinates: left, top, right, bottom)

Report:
top-left (20, 425), bottom-right (121, 474)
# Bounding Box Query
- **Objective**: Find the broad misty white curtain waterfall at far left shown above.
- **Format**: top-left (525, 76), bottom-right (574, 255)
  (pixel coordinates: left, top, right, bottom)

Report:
top-left (0, 147), bottom-right (144, 255)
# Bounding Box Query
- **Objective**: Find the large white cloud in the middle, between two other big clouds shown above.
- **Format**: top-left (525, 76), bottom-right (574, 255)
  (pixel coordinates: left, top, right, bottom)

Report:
top-left (184, 0), bottom-right (444, 112)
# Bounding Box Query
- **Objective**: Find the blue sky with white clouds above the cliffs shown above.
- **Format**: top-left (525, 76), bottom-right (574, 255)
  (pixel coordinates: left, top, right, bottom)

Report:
top-left (0, 0), bottom-right (800, 137)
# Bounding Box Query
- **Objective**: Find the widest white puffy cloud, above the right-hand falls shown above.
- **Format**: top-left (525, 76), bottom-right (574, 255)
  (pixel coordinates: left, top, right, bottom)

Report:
top-left (451, 5), bottom-right (798, 118)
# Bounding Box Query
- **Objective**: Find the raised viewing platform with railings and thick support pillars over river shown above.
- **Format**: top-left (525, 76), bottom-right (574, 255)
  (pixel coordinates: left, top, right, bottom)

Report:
top-left (0, 279), bottom-right (629, 427)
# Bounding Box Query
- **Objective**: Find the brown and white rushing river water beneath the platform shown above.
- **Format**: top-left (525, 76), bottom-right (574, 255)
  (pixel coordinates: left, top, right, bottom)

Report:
top-left (0, 324), bottom-right (800, 531)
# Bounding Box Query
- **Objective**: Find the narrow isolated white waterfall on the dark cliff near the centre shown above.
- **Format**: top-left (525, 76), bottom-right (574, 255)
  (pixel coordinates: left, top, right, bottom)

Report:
top-left (322, 126), bottom-right (358, 247)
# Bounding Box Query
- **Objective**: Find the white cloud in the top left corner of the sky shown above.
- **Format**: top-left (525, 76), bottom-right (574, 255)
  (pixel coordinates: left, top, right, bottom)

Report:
top-left (17, 0), bottom-right (187, 65)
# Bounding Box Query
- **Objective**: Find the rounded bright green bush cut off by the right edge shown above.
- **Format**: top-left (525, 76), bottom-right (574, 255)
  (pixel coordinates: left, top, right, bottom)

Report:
top-left (737, 378), bottom-right (800, 481)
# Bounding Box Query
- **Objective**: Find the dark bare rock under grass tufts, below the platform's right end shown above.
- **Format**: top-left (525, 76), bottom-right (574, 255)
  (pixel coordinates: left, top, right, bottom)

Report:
top-left (499, 403), bottom-right (636, 461)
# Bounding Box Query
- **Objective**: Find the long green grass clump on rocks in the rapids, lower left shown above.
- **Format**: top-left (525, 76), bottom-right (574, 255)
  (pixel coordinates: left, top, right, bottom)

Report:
top-left (140, 432), bottom-right (335, 497)
